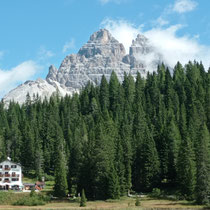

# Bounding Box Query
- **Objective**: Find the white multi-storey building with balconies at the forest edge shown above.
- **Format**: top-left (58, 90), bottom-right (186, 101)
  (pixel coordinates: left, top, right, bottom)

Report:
top-left (0, 158), bottom-right (23, 190)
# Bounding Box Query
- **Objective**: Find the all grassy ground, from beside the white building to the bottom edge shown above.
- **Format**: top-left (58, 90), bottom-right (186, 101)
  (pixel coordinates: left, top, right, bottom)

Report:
top-left (0, 177), bottom-right (207, 210)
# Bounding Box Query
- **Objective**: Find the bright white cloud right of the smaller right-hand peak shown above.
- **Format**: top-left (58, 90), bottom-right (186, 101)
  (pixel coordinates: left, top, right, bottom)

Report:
top-left (144, 25), bottom-right (210, 68)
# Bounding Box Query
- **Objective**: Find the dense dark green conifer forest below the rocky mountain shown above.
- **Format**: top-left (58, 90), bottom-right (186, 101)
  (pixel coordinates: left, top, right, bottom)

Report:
top-left (0, 62), bottom-right (210, 203)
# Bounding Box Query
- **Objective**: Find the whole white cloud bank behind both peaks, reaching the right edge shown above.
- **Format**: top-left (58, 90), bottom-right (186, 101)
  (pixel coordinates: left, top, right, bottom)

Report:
top-left (102, 19), bottom-right (210, 68)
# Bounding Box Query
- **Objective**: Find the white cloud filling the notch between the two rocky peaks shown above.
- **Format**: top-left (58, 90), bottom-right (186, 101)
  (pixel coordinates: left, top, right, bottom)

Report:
top-left (101, 18), bottom-right (143, 53)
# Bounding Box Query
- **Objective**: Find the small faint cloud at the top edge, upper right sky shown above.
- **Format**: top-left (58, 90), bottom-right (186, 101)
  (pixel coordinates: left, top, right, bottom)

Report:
top-left (173, 0), bottom-right (197, 14)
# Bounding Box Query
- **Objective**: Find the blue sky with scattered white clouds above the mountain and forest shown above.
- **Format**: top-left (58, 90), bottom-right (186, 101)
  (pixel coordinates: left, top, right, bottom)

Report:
top-left (0, 0), bottom-right (210, 97)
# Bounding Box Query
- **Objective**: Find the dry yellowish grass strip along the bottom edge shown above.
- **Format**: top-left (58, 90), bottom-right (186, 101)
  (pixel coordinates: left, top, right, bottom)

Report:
top-left (0, 197), bottom-right (206, 210)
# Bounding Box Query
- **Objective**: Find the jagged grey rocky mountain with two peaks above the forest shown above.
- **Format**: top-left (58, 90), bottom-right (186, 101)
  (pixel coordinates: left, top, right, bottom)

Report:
top-left (3, 29), bottom-right (162, 104)
